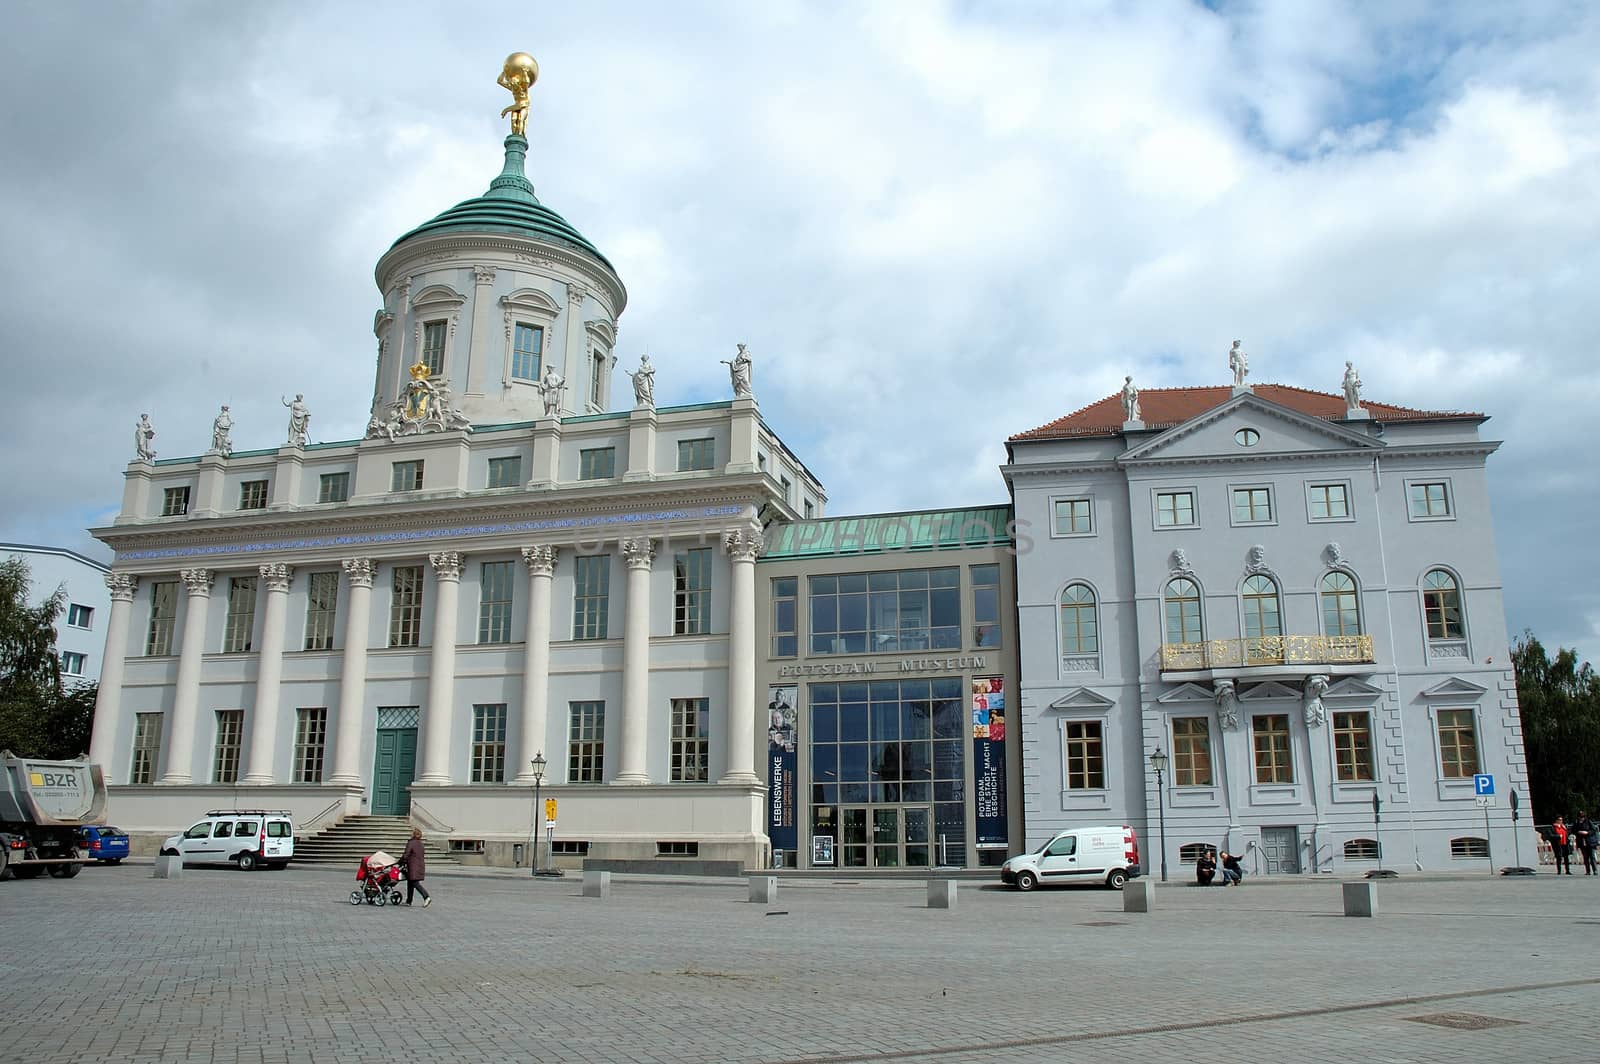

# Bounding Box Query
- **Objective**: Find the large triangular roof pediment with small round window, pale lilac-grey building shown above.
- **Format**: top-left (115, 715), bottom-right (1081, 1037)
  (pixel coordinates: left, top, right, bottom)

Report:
top-left (1118, 385), bottom-right (1384, 462)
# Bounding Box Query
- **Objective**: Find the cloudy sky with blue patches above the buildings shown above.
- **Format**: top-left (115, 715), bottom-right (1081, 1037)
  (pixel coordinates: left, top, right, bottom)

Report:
top-left (0, 0), bottom-right (1600, 656)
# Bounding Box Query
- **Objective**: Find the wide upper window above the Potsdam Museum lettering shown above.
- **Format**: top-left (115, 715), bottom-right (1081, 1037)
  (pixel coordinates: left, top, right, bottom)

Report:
top-left (808, 568), bottom-right (962, 654)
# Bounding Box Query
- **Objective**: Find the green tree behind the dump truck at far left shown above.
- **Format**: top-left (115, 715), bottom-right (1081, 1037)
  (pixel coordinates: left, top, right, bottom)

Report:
top-left (0, 557), bottom-right (99, 758)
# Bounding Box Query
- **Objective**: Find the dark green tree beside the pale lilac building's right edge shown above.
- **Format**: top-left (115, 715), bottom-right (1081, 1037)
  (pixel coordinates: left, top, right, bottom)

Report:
top-left (1510, 632), bottom-right (1600, 822)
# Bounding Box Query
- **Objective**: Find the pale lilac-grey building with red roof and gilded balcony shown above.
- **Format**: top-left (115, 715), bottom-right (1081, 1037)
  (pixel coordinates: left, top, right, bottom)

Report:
top-left (1005, 373), bottom-right (1534, 875)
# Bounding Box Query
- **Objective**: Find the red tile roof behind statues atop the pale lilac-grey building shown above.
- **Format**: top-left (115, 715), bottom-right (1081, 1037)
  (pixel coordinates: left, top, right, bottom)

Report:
top-left (1011, 384), bottom-right (1483, 440)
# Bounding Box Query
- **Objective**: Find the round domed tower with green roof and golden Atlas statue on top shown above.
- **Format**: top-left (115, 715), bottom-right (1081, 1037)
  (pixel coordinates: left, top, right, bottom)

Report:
top-left (373, 51), bottom-right (627, 426)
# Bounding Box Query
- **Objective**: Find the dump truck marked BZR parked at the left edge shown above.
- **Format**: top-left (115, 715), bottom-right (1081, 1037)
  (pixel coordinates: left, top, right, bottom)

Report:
top-left (0, 750), bottom-right (106, 880)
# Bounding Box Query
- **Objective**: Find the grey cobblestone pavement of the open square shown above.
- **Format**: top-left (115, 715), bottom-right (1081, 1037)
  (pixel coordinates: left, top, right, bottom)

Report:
top-left (0, 864), bottom-right (1600, 1064)
